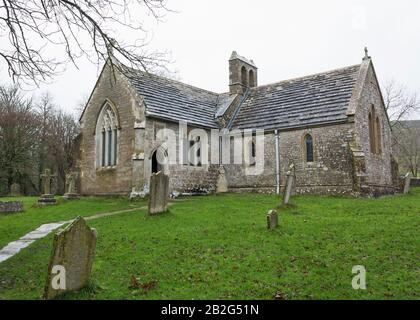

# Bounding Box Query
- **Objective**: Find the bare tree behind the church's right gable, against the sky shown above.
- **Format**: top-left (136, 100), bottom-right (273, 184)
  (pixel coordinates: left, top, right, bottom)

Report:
top-left (384, 80), bottom-right (420, 127)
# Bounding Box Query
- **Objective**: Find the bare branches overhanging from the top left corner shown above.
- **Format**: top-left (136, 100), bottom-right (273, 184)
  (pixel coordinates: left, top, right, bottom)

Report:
top-left (0, 0), bottom-right (167, 84)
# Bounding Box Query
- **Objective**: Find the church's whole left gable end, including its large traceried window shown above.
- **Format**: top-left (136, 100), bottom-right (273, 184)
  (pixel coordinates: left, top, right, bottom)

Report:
top-left (78, 62), bottom-right (144, 194)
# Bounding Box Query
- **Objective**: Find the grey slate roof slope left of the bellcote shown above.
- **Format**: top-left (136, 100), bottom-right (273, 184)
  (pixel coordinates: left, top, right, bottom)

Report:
top-left (126, 71), bottom-right (219, 128)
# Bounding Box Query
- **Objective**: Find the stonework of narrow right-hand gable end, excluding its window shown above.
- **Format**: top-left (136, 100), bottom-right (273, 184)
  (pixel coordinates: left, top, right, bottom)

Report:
top-left (355, 65), bottom-right (394, 194)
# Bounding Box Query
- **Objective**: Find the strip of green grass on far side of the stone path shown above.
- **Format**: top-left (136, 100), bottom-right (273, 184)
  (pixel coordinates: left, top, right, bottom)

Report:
top-left (0, 197), bottom-right (144, 249)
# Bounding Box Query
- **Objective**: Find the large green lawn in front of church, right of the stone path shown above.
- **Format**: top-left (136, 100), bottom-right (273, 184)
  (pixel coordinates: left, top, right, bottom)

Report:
top-left (0, 189), bottom-right (420, 299)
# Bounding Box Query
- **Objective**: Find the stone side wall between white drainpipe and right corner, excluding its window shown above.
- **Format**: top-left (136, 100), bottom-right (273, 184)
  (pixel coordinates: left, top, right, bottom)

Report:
top-left (280, 123), bottom-right (354, 194)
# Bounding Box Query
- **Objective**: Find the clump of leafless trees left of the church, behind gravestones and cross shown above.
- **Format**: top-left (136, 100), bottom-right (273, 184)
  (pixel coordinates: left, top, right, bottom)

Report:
top-left (0, 86), bottom-right (79, 194)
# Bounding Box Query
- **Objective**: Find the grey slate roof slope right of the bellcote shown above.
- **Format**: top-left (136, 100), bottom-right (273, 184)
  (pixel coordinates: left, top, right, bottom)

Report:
top-left (232, 65), bottom-right (360, 130)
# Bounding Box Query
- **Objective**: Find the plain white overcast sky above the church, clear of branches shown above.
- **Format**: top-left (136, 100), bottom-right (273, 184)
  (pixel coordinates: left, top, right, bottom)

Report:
top-left (0, 0), bottom-right (420, 118)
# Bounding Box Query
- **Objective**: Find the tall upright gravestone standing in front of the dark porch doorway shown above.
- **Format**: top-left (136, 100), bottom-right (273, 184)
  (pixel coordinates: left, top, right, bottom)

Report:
top-left (149, 171), bottom-right (169, 215)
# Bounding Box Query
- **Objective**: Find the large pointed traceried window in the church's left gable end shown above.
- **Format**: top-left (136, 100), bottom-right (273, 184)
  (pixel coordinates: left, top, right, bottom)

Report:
top-left (96, 102), bottom-right (119, 167)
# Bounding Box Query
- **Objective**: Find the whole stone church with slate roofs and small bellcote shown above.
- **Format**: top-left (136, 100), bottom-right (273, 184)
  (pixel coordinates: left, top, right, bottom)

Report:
top-left (78, 50), bottom-right (397, 196)
